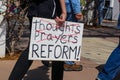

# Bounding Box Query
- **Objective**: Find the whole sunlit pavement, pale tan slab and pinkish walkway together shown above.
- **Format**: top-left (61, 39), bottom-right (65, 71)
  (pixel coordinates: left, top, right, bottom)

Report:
top-left (0, 37), bottom-right (118, 80)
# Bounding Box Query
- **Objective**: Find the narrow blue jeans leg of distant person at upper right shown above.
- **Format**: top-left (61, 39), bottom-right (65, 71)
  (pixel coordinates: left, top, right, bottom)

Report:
top-left (98, 0), bottom-right (104, 25)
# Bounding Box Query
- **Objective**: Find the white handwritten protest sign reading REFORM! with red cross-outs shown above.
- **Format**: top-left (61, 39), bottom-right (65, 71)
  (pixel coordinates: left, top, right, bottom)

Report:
top-left (29, 17), bottom-right (84, 61)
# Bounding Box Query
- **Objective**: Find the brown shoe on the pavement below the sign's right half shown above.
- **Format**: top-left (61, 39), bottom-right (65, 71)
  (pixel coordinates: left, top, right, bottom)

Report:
top-left (64, 64), bottom-right (83, 71)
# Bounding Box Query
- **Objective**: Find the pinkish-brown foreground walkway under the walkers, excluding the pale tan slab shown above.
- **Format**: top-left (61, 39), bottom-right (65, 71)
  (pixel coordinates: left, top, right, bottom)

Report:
top-left (0, 58), bottom-right (98, 80)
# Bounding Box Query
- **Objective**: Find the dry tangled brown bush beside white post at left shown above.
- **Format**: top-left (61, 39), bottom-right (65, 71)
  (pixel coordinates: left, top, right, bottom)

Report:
top-left (0, 0), bottom-right (27, 55)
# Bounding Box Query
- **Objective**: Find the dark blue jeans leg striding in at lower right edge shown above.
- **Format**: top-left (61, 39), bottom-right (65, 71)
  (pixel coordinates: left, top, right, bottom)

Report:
top-left (98, 44), bottom-right (120, 80)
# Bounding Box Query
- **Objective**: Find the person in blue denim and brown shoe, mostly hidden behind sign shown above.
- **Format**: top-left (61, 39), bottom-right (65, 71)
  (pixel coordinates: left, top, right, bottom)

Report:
top-left (64, 0), bottom-right (83, 71)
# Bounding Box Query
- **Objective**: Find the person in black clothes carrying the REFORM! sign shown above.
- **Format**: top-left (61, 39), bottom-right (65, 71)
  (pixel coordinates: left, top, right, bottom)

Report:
top-left (8, 0), bottom-right (66, 80)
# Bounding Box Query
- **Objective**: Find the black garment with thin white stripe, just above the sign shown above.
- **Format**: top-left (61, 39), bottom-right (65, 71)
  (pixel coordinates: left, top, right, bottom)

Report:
top-left (27, 0), bottom-right (61, 18)
